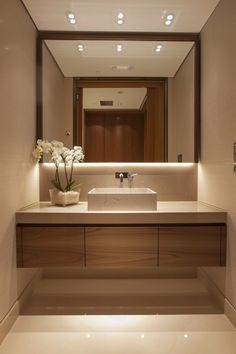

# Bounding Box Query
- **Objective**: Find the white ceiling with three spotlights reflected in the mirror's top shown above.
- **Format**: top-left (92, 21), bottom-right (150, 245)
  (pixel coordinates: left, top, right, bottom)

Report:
top-left (46, 40), bottom-right (194, 77)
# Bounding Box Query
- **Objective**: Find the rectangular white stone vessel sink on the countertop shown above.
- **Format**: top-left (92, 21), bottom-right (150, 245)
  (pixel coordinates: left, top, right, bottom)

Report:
top-left (88, 188), bottom-right (157, 211)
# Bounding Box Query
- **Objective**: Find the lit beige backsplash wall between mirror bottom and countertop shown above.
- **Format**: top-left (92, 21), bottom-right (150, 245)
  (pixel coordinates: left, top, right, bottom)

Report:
top-left (40, 164), bottom-right (197, 201)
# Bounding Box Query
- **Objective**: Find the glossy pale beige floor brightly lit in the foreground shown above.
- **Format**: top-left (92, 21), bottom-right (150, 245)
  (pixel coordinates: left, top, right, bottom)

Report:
top-left (0, 314), bottom-right (236, 354)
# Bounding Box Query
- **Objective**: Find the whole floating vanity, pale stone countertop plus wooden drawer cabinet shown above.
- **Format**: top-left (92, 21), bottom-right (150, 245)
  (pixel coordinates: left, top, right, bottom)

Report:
top-left (16, 202), bottom-right (227, 268)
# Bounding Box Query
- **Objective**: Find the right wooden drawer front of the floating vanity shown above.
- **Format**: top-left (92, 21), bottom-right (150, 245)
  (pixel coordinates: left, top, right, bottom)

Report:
top-left (159, 226), bottom-right (225, 266)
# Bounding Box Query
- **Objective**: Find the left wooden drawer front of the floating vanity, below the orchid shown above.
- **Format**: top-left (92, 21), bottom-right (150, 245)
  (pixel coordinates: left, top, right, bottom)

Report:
top-left (17, 226), bottom-right (84, 268)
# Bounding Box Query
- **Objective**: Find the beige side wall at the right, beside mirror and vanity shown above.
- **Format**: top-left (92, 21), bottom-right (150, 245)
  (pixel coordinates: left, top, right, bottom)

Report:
top-left (198, 0), bottom-right (236, 306)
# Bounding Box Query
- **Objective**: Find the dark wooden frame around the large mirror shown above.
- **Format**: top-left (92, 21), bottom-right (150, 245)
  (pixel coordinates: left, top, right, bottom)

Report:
top-left (36, 31), bottom-right (200, 163)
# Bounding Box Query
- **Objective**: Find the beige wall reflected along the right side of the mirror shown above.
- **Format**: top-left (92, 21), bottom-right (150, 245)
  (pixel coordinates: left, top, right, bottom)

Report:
top-left (168, 49), bottom-right (194, 162)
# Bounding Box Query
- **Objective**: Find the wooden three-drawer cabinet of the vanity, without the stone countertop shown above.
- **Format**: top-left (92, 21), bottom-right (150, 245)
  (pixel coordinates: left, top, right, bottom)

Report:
top-left (17, 224), bottom-right (226, 268)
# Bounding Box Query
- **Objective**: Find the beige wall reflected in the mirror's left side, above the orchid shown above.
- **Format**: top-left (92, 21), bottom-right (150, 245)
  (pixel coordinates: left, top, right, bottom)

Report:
top-left (43, 45), bottom-right (73, 147)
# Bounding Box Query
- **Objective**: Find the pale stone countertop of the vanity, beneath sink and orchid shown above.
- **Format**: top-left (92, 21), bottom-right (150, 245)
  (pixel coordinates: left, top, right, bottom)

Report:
top-left (16, 201), bottom-right (227, 224)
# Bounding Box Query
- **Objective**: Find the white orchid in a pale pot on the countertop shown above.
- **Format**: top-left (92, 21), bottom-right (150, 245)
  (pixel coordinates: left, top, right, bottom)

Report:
top-left (33, 139), bottom-right (84, 206)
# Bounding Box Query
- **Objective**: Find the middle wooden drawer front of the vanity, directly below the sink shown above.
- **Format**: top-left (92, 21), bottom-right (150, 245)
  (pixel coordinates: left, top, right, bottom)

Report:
top-left (85, 227), bottom-right (158, 267)
